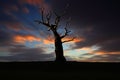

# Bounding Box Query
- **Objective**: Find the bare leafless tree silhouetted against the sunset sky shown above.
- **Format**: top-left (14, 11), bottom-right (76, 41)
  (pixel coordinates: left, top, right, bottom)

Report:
top-left (35, 8), bottom-right (74, 62)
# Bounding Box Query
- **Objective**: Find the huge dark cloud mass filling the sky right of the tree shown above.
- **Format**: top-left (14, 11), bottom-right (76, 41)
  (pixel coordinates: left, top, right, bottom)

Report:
top-left (52, 0), bottom-right (120, 51)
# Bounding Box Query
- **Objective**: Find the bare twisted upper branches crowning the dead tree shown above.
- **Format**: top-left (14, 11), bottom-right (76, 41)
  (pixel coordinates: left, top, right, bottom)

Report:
top-left (35, 5), bottom-right (70, 31)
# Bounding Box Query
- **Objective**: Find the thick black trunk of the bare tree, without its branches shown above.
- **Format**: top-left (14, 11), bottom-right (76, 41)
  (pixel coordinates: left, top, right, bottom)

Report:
top-left (53, 31), bottom-right (66, 62)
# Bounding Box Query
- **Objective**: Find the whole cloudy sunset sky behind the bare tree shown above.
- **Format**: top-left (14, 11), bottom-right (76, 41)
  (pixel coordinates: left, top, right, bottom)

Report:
top-left (0, 0), bottom-right (120, 62)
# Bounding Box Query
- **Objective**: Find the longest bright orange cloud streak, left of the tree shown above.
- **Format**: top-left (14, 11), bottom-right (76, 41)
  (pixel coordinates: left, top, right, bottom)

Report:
top-left (13, 35), bottom-right (41, 43)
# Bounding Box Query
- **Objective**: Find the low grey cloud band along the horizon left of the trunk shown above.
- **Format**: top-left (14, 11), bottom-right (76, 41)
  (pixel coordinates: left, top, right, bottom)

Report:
top-left (0, 53), bottom-right (54, 62)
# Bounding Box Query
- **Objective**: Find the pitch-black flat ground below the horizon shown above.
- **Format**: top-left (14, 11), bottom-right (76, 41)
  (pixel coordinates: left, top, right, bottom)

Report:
top-left (0, 62), bottom-right (120, 80)
